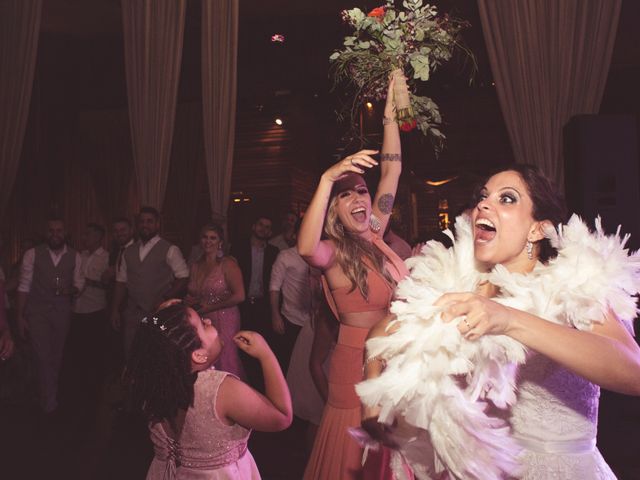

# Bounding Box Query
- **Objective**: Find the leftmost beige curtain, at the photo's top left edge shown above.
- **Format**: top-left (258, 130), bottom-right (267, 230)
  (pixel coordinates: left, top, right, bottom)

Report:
top-left (0, 0), bottom-right (42, 218)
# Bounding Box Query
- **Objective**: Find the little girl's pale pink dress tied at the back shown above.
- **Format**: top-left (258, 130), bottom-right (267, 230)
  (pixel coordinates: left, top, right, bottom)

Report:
top-left (147, 370), bottom-right (260, 480)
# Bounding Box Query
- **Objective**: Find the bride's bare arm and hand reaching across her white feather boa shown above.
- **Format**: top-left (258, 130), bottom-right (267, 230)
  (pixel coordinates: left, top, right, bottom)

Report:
top-left (436, 293), bottom-right (640, 395)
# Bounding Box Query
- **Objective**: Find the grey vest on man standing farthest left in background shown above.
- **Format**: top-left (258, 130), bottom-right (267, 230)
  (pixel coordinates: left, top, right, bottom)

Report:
top-left (25, 245), bottom-right (76, 315)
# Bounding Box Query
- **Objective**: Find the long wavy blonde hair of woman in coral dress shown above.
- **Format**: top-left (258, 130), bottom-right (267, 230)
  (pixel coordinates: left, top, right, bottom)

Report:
top-left (324, 195), bottom-right (396, 300)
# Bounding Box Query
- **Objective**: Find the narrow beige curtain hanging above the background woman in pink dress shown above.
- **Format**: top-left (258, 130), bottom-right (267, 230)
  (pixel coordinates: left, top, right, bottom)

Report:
top-left (202, 0), bottom-right (239, 223)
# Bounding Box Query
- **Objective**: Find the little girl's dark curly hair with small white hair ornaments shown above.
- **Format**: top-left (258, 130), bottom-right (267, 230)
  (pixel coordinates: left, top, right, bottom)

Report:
top-left (125, 304), bottom-right (202, 422)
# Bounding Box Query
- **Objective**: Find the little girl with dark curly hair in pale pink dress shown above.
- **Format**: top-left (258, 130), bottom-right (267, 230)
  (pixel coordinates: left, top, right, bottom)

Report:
top-left (127, 301), bottom-right (292, 480)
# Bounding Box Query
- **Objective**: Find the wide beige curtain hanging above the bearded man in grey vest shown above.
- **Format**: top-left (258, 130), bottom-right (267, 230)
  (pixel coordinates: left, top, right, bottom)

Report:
top-left (122, 0), bottom-right (186, 209)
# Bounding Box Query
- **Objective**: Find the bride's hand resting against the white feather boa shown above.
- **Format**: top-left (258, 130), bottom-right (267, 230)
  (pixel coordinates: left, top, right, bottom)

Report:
top-left (434, 293), bottom-right (511, 340)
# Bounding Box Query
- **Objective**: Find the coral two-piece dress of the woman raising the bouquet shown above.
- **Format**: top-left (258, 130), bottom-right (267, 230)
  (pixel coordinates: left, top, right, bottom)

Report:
top-left (304, 240), bottom-right (409, 480)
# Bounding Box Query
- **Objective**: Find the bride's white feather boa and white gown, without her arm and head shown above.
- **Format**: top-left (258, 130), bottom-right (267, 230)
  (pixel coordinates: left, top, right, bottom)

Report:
top-left (356, 217), bottom-right (640, 480)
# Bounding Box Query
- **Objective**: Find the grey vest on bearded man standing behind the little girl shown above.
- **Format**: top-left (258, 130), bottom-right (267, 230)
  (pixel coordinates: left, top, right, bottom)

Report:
top-left (124, 238), bottom-right (173, 313)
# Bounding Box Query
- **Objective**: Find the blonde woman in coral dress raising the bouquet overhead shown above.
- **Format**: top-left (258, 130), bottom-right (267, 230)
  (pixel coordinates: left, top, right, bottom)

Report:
top-left (298, 73), bottom-right (408, 480)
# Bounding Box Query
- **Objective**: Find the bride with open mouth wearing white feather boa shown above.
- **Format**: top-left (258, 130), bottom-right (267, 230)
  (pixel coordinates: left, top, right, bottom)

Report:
top-left (357, 165), bottom-right (640, 480)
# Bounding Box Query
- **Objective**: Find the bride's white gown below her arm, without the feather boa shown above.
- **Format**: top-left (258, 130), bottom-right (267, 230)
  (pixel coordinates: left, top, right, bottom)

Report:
top-left (509, 354), bottom-right (616, 480)
